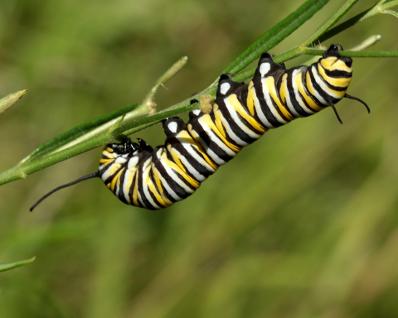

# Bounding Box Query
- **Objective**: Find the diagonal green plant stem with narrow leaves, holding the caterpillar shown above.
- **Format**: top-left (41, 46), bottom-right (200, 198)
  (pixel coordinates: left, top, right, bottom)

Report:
top-left (0, 0), bottom-right (398, 184)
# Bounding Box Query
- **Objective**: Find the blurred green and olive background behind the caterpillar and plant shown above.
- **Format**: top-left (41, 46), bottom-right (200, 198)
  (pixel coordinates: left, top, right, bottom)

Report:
top-left (0, 0), bottom-right (398, 318)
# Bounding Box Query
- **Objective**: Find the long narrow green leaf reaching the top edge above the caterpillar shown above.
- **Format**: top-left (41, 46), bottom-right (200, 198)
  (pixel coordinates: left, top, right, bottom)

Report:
top-left (224, 0), bottom-right (329, 74)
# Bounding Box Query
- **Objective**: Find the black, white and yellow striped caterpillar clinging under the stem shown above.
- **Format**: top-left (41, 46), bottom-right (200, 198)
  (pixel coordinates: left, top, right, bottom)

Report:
top-left (30, 45), bottom-right (370, 211)
